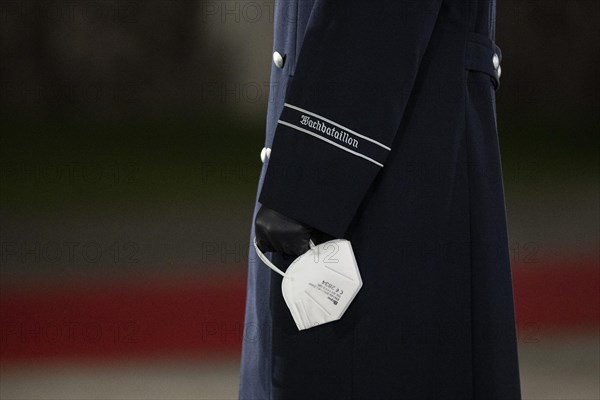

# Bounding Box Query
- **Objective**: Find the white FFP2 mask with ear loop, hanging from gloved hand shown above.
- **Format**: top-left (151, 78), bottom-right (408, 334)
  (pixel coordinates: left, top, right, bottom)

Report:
top-left (254, 238), bottom-right (362, 330)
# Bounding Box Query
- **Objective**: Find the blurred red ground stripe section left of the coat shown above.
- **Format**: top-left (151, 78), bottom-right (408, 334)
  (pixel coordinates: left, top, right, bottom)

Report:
top-left (0, 276), bottom-right (245, 361)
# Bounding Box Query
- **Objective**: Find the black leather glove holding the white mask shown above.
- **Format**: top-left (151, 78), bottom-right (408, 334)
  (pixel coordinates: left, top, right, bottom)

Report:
top-left (254, 206), bottom-right (333, 256)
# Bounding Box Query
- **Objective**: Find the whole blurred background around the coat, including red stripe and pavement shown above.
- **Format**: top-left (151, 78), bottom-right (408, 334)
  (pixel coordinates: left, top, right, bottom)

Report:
top-left (0, 0), bottom-right (600, 399)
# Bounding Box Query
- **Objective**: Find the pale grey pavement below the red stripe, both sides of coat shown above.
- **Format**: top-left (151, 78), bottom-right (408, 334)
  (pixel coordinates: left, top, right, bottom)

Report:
top-left (0, 334), bottom-right (600, 400)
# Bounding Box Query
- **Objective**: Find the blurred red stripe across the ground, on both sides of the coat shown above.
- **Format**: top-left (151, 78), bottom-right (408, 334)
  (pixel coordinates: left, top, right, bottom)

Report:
top-left (0, 263), bottom-right (600, 362)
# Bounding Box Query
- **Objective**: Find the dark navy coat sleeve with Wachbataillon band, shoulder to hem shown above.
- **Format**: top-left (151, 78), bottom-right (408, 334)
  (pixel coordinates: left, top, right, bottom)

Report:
top-left (259, 0), bottom-right (441, 237)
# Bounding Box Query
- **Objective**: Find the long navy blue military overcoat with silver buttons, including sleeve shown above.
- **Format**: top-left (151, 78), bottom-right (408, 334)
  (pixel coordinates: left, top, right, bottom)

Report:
top-left (240, 0), bottom-right (520, 400)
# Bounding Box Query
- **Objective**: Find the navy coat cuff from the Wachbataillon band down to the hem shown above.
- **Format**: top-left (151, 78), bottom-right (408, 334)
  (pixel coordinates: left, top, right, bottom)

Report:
top-left (259, 103), bottom-right (389, 238)
